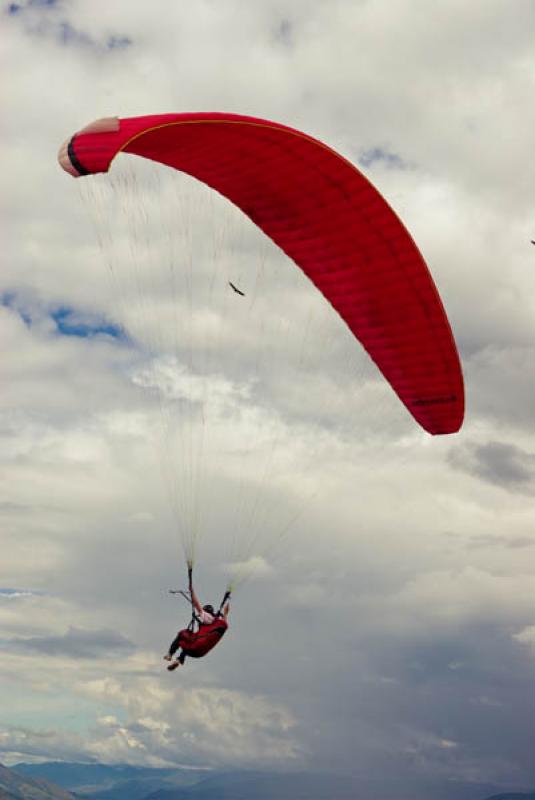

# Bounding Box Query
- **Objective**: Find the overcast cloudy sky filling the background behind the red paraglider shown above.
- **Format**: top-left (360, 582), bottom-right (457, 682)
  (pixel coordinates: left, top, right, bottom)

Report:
top-left (0, 0), bottom-right (535, 788)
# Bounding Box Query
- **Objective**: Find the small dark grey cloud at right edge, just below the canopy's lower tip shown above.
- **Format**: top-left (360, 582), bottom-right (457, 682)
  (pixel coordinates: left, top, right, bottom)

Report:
top-left (448, 441), bottom-right (535, 494)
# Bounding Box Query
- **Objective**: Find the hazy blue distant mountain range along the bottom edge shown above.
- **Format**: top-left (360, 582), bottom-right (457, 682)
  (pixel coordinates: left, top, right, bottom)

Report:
top-left (9, 762), bottom-right (535, 800)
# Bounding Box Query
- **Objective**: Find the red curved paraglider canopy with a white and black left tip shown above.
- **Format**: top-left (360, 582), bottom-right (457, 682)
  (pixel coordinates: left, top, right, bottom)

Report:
top-left (59, 113), bottom-right (464, 434)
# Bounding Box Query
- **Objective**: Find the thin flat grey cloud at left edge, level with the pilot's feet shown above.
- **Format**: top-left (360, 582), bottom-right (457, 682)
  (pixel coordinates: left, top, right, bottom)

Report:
top-left (4, 628), bottom-right (134, 658)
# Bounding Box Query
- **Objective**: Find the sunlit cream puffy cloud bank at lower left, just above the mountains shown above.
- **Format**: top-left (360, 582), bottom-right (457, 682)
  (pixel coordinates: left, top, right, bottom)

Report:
top-left (0, 673), bottom-right (301, 768)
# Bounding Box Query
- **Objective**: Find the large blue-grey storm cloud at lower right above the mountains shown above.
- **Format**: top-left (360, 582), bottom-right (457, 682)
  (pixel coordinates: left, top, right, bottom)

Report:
top-left (270, 608), bottom-right (535, 786)
